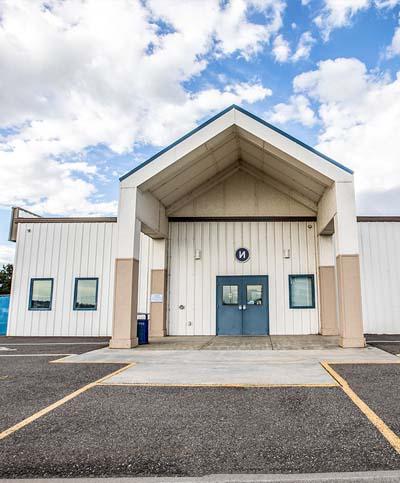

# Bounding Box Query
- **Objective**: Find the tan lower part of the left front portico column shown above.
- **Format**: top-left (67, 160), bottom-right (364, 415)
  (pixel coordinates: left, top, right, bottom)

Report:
top-left (110, 258), bottom-right (139, 349)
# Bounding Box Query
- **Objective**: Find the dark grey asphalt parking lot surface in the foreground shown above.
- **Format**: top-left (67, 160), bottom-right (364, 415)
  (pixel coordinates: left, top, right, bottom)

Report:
top-left (0, 339), bottom-right (400, 478)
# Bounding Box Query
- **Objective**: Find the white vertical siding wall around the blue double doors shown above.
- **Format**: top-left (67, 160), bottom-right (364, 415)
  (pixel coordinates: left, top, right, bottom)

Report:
top-left (168, 222), bottom-right (319, 335)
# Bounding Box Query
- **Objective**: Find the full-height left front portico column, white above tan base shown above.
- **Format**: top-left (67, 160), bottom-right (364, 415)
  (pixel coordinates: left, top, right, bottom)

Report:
top-left (110, 188), bottom-right (141, 349)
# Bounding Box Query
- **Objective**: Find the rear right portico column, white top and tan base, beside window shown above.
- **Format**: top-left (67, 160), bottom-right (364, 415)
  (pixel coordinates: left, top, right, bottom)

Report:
top-left (318, 235), bottom-right (339, 335)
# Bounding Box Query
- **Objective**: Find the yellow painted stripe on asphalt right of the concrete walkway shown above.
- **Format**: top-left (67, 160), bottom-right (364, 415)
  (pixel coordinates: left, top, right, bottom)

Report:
top-left (321, 362), bottom-right (400, 453)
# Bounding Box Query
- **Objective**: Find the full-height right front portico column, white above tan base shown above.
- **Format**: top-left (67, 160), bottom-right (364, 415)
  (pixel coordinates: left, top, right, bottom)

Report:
top-left (334, 182), bottom-right (365, 347)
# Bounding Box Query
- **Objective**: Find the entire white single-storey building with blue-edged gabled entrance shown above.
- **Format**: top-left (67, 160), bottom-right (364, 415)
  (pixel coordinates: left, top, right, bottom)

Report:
top-left (8, 106), bottom-right (400, 348)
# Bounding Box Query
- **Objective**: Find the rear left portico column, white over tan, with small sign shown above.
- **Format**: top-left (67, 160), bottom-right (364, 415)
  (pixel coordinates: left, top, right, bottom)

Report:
top-left (150, 239), bottom-right (168, 337)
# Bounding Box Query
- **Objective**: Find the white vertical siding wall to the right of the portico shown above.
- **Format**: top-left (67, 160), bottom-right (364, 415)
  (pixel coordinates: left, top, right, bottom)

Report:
top-left (358, 222), bottom-right (400, 334)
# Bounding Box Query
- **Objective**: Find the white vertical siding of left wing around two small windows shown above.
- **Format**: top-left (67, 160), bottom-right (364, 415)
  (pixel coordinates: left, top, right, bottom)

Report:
top-left (8, 223), bottom-right (152, 336)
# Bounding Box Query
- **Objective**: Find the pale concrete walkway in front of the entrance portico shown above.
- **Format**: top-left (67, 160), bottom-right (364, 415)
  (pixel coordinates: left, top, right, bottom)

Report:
top-left (57, 347), bottom-right (399, 385)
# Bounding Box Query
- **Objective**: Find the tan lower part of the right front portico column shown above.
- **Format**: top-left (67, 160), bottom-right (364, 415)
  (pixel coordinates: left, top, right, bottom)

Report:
top-left (336, 254), bottom-right (365, 347)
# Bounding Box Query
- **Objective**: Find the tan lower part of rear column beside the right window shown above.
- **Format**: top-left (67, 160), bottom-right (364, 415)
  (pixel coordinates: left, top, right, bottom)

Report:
top-left (319, 266), bottom-right (339, 335)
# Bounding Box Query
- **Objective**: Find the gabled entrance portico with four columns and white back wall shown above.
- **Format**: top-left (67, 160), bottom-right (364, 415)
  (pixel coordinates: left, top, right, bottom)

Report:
top-left (110, 106), bottom-right (364, 348)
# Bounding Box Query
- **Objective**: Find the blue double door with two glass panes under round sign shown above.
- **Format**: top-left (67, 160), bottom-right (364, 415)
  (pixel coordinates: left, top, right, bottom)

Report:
top-left (217, 275), bottom-right (269, 335)
